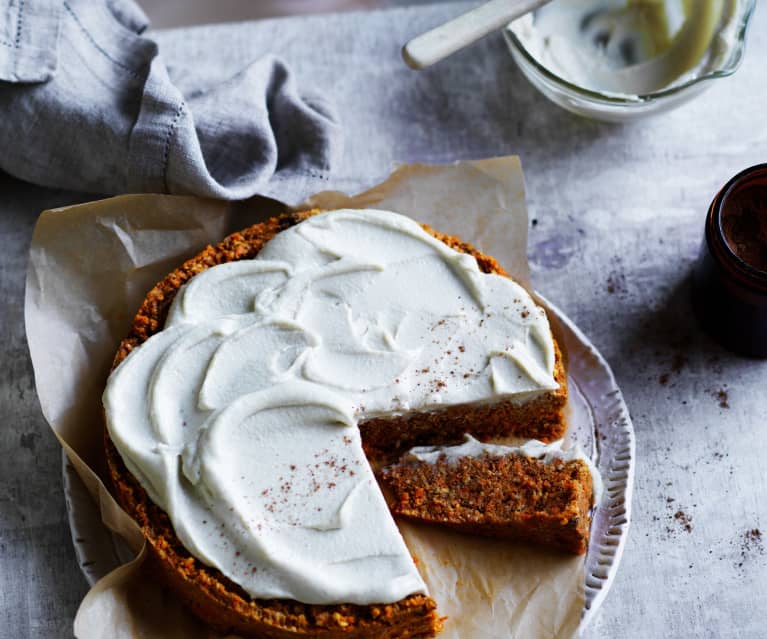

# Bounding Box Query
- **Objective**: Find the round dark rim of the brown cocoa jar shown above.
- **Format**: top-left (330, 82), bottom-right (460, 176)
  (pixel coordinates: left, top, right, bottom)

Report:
top-left (706, 163), bottom-right (767, 293)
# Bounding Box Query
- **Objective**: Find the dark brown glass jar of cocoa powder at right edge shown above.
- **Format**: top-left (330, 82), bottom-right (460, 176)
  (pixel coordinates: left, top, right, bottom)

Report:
top-left (693, 164), bottom-right (767, 358)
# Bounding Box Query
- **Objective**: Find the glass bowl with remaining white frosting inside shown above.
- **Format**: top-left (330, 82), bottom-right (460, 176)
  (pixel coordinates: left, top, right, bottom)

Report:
top-left (504, 0), bottom-right (756, 121)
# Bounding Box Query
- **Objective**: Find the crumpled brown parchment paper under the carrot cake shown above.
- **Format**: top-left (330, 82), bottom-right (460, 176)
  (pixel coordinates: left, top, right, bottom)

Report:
top-left (25, 157), bottom-right (584, 639)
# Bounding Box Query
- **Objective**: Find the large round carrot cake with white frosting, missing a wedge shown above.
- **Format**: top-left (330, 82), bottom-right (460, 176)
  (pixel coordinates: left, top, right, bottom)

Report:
top-left (104, 210), bottom-right (567, 639)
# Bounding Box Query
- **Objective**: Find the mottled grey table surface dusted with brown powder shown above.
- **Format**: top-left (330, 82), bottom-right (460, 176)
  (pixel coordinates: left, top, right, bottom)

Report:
top-left (0, 4), bottom-right (767, 639)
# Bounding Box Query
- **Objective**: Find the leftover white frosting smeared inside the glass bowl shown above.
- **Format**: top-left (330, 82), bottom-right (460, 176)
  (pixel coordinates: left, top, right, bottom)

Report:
top-left (510, 0), bottom-right (739, 98)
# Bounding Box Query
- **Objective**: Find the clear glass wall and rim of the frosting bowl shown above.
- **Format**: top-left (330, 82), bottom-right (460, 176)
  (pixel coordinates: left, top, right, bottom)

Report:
top-left (503, 0), bottom-right (756, 122)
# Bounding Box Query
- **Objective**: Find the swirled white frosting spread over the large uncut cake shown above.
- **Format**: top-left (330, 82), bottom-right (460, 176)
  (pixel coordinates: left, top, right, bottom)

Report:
top-left (103, 210), bottom-right (557, 604)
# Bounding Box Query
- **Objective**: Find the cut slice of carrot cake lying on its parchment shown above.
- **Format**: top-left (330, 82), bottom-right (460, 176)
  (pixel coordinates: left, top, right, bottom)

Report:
top-left (379, 435), bottom-right (601, 554)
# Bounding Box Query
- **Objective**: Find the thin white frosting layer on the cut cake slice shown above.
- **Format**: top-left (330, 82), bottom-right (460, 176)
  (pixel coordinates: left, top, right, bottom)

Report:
top-left (406, 433), bottom-right (604, 505)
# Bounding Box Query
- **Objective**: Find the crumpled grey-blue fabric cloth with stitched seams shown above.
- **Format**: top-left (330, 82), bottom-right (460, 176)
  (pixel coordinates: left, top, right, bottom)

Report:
top-left (0, 0), bottom-right (342, 204)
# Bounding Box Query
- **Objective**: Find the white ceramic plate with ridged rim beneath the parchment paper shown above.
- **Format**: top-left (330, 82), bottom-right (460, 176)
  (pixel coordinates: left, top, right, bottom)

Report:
top-left (62, 300), bottom-right (634, 629)
